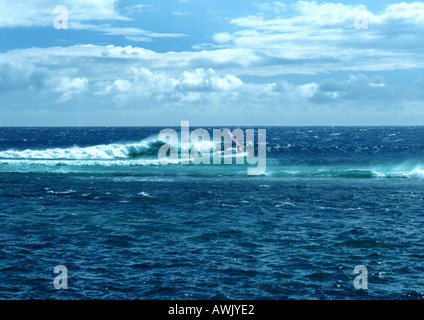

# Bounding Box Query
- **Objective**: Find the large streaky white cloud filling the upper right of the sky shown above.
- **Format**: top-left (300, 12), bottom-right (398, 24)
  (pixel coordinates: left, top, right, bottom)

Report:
top-left (204, 1), bottom-right (424, 76)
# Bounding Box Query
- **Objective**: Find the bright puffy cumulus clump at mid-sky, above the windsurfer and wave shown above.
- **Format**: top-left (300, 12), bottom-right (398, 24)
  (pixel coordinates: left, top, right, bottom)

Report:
top-left (95, 67), bottom-right (245, 107)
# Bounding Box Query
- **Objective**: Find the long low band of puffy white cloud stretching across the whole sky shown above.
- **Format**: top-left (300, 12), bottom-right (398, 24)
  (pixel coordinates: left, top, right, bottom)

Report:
top-left (0, 40), bottom-right (423, 112)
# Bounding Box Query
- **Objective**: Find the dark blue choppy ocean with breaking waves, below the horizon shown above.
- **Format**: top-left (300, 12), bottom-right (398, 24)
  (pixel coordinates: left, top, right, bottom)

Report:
top-left (0, 127), bottom-right (424, 299)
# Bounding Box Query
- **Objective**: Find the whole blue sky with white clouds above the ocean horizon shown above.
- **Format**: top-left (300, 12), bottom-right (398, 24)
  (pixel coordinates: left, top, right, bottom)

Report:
top-left (0, 0), bottom-right (424, 126)
